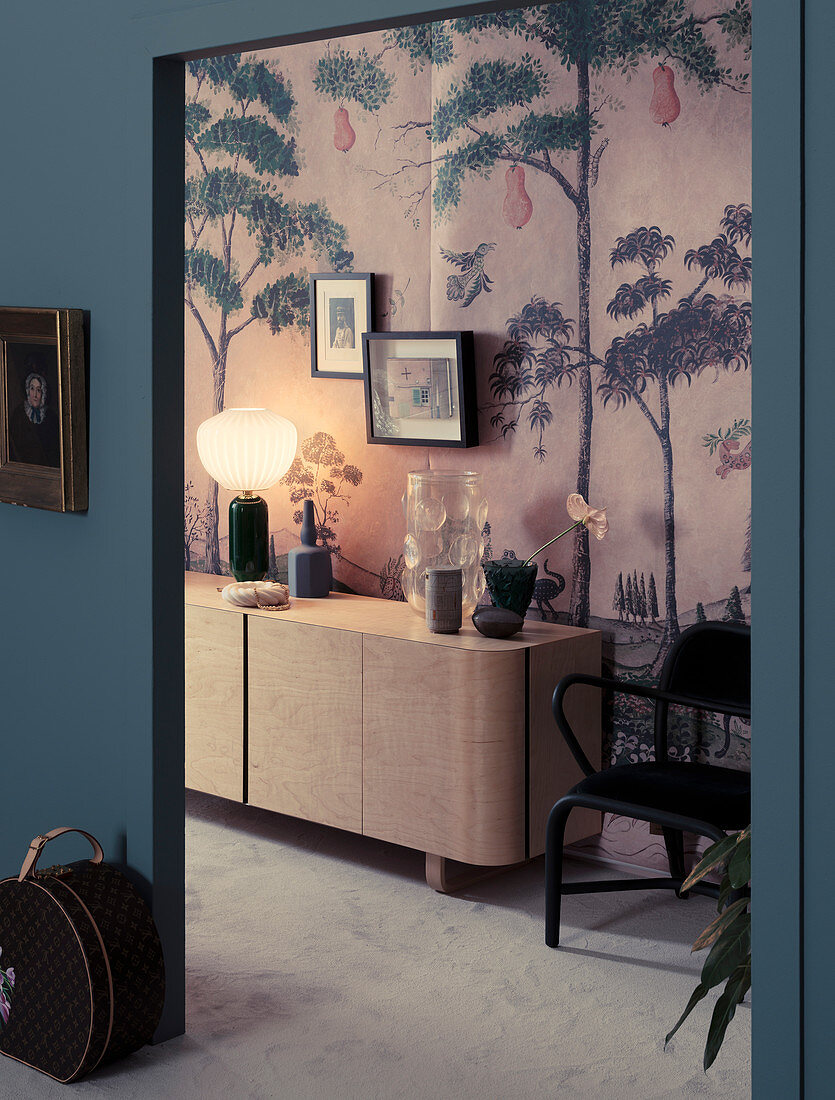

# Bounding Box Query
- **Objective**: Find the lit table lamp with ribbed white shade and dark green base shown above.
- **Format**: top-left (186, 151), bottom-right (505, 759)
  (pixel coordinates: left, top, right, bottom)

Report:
top-left (197, 409), bottom-right (298, 581)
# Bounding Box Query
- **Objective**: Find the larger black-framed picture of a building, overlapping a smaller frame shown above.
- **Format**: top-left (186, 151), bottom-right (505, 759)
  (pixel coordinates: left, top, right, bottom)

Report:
top-left (362, 332), bottom-right (479, 447)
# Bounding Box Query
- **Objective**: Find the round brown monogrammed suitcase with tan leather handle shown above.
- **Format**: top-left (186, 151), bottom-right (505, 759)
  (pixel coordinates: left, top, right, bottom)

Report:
top-left (0, 828), bottom-right (165, 1082)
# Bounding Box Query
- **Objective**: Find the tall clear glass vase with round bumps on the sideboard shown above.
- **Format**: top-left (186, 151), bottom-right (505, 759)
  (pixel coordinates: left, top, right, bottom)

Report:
top-left (400, 470), bottom-right (487, 615)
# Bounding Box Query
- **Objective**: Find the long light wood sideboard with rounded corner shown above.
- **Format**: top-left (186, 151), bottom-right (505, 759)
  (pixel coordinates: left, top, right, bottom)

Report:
top-left (186, 573), bottom-right (601, 889)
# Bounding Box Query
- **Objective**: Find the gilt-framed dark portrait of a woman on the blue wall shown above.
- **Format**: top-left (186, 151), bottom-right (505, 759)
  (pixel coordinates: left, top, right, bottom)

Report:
top-left (0, 308), bottom-right (87, 512)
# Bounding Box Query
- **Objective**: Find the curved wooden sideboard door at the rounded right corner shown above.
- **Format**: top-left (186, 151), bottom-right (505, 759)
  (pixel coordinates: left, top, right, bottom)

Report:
top-left (363, 635), bottom-right (526, 866)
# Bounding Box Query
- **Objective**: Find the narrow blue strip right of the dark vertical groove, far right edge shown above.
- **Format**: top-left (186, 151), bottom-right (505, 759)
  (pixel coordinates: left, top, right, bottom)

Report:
top-left (792, 0), bottom-right (835, 1098)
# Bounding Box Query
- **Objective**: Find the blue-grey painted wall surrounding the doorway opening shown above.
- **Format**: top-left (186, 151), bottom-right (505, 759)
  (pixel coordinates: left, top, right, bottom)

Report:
top-left (0, 0), bottom-right (835, 1098)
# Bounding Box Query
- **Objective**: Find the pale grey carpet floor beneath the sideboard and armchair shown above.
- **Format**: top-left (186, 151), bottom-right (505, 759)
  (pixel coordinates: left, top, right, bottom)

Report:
top-left (0, 793), bottom-right (750, 1100)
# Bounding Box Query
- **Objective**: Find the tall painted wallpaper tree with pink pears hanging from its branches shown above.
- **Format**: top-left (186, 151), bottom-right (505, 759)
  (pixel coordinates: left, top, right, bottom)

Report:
top-left (316, 0), bottom-right (750, 626)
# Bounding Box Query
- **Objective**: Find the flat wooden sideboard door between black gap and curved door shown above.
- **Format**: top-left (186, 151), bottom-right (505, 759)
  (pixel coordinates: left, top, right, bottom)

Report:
top-left (246, 613), bottom-right (362, 833)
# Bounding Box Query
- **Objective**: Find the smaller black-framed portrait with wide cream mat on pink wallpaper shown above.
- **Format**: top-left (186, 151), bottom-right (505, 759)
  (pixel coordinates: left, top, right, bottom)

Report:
top-left (310, 272), bottom-right (374, 378)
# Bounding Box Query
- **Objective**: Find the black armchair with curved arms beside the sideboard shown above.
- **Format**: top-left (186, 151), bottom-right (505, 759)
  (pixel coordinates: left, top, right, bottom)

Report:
top-left (545, 623), bottom-right (750, 947)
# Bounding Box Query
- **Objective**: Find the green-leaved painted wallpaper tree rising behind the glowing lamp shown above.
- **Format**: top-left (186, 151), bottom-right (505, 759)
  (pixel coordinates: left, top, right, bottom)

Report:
top-left (185, 54), bottom-right (353, 573)
